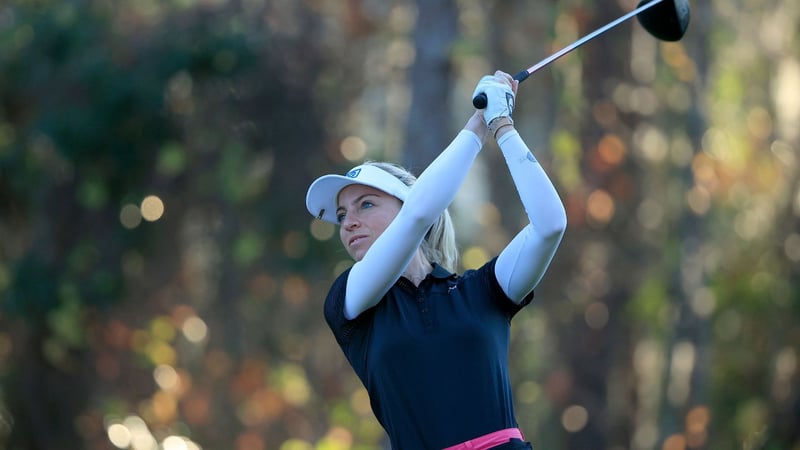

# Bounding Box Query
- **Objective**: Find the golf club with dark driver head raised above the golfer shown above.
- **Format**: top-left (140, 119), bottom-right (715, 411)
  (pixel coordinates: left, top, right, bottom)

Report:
top-left (472, 0), bottom-right (690, 109)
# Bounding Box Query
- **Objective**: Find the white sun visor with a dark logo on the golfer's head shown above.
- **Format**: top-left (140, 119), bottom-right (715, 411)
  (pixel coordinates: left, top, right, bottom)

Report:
top-left (306, 164), bottom-right (411, 224)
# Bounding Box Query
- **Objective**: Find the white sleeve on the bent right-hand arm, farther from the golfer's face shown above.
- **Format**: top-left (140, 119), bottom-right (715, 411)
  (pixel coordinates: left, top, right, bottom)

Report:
top-left (495, 130), bottom-right (567, 303)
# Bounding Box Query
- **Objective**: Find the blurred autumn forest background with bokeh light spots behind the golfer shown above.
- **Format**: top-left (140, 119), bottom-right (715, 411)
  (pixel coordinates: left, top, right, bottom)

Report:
top-left (0, 0), bottom-right (800, 450)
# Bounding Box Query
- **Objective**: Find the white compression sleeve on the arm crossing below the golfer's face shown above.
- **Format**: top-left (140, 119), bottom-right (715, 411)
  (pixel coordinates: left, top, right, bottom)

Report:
top-left (344, 130), bottom-right (482, 319)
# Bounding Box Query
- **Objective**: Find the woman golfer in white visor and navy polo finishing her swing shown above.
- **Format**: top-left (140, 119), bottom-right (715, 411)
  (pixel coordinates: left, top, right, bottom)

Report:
top-left (306, 71), bottom-right (566, 450)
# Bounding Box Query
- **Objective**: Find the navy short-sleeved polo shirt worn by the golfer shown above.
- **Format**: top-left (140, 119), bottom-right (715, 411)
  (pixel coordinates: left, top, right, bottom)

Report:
top-left (325, 258), bottom-right (533, 450)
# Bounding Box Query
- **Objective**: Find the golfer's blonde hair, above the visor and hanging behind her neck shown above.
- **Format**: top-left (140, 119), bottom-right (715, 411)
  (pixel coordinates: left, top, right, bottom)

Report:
top-left (364, 161), bottom-right (458, 272)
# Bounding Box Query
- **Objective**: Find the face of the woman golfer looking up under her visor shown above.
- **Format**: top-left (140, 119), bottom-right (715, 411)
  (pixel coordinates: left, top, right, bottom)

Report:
top-left (336, 184), bottom-right (402, 261)
